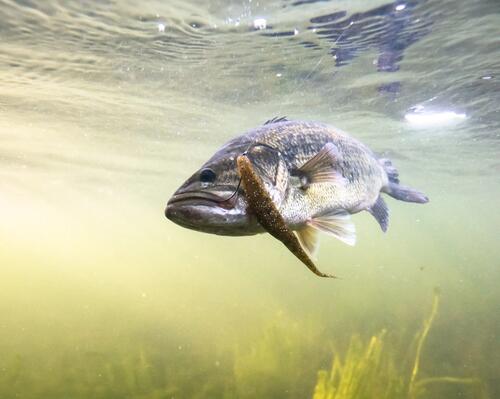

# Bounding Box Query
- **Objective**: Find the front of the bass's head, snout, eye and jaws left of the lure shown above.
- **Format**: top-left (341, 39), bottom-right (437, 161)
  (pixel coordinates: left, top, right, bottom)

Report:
top-left (165, 154), bottom-right (258, 236)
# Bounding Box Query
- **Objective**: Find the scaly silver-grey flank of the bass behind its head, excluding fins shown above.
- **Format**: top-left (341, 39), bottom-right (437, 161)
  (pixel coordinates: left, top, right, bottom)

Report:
top-left (245, 121), bottom-right (387, 226)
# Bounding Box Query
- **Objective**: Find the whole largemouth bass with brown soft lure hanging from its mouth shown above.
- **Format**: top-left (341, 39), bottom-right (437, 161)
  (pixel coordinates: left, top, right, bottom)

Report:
top-left (165, 118), bottom-right (428, 275)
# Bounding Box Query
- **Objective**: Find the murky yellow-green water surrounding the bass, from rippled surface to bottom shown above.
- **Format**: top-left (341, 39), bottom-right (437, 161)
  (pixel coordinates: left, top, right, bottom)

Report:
top-left (0, 0), bottom-right (500, 399)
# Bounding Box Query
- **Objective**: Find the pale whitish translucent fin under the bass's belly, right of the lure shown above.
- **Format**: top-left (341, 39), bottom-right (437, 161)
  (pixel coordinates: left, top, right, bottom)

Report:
top-left (307, 210), bottom-right (356, 245)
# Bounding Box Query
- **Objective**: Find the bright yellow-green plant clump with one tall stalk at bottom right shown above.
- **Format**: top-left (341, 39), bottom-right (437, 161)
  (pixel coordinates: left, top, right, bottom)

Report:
top-left (313, 289), bottom-right (486, 399)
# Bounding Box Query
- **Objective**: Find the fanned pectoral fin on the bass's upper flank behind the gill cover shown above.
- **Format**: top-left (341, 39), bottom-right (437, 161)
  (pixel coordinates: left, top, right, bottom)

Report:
top-left (299, 143), bottom-right (344, 184)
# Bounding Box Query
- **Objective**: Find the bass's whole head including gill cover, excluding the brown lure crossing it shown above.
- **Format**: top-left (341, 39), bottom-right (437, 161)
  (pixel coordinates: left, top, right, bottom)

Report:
top-left (165, 138), bottom-right (288, 236)
